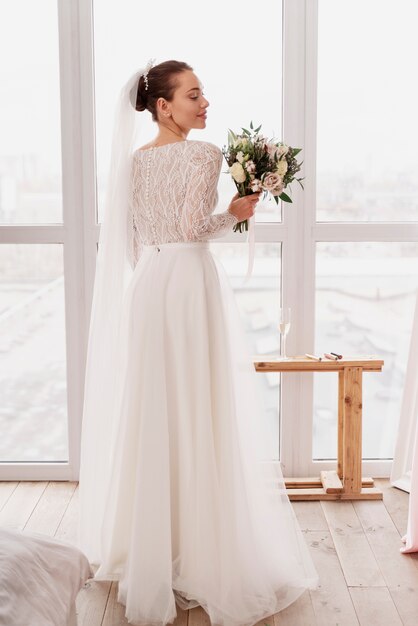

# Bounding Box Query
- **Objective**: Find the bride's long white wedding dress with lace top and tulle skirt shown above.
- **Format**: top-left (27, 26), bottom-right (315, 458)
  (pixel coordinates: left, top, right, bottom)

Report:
top-left (80, 140), bottom-right (318, 626)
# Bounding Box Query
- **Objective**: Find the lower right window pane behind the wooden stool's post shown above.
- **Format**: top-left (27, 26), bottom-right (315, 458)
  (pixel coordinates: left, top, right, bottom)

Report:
top-left (313, 242), bottom-right (418, 459)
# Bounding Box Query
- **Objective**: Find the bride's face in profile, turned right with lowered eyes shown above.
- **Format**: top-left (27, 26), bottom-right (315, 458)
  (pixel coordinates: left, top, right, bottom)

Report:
top-left (158, 70), bottom-right (209, 132)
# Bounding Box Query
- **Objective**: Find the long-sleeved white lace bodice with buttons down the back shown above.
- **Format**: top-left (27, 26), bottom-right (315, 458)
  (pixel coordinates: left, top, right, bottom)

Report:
top-left (128, 140), bottom-right (238, 267)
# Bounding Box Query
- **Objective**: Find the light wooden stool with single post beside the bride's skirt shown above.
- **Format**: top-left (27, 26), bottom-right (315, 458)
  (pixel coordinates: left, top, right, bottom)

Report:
top-left (253, 356), bottom-right (384, 500)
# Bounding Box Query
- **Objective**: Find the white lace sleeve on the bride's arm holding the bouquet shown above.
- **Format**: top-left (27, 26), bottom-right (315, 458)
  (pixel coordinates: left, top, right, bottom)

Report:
top-left (183, 144), bottom-right (238, 240)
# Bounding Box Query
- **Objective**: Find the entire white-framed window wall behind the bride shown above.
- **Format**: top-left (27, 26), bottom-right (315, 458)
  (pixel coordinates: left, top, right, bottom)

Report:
top-left (0, 0), bottom-right (418, 479)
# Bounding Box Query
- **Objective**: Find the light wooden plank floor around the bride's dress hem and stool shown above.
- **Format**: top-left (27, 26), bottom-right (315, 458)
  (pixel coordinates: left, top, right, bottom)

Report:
top-left (0, 479), bottom-right (418, 626)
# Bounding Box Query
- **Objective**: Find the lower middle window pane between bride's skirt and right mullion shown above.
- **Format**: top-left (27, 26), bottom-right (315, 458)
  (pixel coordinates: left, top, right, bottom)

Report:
top-left (210, 242), bottom-right (282, 460)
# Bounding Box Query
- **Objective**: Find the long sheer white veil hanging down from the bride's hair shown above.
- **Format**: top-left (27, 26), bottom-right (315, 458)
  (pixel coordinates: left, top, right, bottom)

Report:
top-left (78, 60), bottom-right (153, 563)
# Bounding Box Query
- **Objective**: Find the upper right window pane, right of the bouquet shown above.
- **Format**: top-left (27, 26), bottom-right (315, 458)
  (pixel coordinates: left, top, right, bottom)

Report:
top-left (317, 0), bottom-right (418, 222)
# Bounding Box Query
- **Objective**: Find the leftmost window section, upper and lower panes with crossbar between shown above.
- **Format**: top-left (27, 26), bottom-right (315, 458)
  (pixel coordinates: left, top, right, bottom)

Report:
top-left (0, 0), bottom-right (69, 468)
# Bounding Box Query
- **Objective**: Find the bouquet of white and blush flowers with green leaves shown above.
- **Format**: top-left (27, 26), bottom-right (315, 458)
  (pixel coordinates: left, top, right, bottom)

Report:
top-left (222, 121), bottom-right (304, 232)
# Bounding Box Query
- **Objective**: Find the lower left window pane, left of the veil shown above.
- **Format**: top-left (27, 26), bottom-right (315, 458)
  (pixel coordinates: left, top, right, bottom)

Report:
top-left (0, 244), bottom-right (68, 462)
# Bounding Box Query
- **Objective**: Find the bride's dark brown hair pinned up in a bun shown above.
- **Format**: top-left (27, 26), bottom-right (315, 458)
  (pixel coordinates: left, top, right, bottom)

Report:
top-left (135, 60), bottom-right (193, 122)
